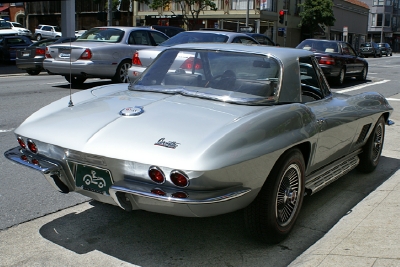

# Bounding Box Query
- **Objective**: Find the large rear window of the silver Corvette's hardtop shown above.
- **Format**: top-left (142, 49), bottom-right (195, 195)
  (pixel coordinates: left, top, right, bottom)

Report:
top-left (129, 48), bottom-right (280, 105)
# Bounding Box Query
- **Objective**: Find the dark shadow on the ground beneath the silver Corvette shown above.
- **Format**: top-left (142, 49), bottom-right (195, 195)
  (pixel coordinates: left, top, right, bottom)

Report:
top-left (40, 157), bottom-right (400, 267)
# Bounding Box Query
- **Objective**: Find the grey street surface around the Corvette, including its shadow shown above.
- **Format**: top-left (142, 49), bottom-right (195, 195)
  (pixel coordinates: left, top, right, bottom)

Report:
top-left (0, 57), bottom-right (400, 267)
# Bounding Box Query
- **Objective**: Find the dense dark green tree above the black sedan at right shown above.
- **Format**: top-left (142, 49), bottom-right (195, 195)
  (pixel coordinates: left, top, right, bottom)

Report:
top-left (299, 0), bottom-right (336, 37)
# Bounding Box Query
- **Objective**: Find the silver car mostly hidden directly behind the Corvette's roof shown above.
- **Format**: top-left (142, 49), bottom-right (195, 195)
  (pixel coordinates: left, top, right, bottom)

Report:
top-left (128, 30), bottom-right (259, 81)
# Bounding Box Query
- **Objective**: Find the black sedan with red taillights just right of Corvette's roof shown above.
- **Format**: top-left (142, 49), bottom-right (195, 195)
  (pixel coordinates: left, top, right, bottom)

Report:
top-left (296, 39), bottom-right (368, 85)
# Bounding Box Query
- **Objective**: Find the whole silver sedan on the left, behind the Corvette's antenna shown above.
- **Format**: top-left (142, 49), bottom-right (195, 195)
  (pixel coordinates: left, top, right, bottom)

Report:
top-left (43, 26), bottom-right (168, 84)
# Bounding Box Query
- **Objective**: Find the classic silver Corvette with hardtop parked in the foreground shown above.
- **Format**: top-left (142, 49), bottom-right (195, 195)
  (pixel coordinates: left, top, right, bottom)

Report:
top-left (5, 43), bottom-right (392, 243)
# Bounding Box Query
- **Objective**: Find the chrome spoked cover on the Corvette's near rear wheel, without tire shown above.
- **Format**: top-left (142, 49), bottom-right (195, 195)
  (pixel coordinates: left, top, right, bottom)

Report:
top-left (275, 164), bottom-right (302, 227)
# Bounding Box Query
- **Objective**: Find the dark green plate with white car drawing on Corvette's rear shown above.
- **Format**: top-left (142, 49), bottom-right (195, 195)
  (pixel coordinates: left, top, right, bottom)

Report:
top-left (75, 164), bottom-right (112, 195)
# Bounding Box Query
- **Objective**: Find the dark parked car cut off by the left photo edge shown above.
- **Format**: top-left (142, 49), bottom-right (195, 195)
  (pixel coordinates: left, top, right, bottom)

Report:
top-left (0, 36), bottom-right (33, 63)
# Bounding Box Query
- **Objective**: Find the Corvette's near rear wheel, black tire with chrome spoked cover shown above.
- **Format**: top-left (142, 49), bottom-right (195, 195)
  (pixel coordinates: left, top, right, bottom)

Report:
top-left (244, 149), bottom-right (305, 244)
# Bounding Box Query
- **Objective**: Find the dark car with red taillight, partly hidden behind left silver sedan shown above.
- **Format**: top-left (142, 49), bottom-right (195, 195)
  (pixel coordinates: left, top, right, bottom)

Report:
top-left (15, 37), bottom-right (76, 75)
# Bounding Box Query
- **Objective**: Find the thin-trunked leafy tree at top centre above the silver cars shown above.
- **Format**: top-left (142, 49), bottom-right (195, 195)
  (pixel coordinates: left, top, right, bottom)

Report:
top-left (145, 0), bottom-right (218, 30)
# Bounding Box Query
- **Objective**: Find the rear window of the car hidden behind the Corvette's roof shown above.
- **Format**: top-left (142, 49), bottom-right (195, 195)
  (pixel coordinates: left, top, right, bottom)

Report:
top-left (160, 32), bottom-right (229, 46)
